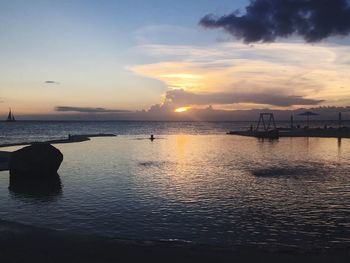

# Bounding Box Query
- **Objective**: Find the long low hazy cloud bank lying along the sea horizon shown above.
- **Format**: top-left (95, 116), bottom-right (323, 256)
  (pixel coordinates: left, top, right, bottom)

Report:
top-left (18, 105), bottom-right (350, 121)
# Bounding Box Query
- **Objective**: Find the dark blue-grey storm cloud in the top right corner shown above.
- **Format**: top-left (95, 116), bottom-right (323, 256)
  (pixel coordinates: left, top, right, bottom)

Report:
top-left (200, 0), bottom-right (350, 43)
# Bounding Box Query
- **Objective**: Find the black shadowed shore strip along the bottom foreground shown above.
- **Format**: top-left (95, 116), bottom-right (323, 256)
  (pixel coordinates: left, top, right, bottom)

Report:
top-left (0, 219), bottom-right (350, 263)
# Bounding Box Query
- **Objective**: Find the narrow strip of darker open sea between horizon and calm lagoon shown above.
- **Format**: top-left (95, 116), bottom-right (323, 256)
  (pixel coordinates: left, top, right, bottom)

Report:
top-left (0, 120), bottom-right (350, 145)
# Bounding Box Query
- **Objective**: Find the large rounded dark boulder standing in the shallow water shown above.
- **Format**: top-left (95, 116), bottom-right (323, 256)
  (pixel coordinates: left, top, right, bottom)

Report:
top-left (9, 143), bottom-right (63, 178)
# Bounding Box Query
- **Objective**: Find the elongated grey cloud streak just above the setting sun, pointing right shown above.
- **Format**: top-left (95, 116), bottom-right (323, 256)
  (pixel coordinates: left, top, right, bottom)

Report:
top-left (166, 90), bottom-right (322, 107)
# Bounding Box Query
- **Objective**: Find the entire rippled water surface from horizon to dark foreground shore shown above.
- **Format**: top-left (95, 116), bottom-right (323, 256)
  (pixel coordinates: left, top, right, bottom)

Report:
top-left (0, 121), bottom-right (350, 250)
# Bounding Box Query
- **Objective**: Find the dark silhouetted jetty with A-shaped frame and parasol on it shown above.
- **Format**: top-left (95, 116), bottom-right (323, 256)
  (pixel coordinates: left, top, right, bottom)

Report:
top-left (227, 112), bottom-right (350, 139)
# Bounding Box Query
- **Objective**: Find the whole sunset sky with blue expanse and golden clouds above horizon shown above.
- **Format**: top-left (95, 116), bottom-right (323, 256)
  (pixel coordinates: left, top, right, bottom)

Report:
top-left (0, 0), bottom-right (350, 120)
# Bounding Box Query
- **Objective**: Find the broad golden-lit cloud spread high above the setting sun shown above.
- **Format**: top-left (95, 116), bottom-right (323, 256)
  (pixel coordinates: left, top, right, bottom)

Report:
top-left (129, 43), bottom-right (350, 109)
